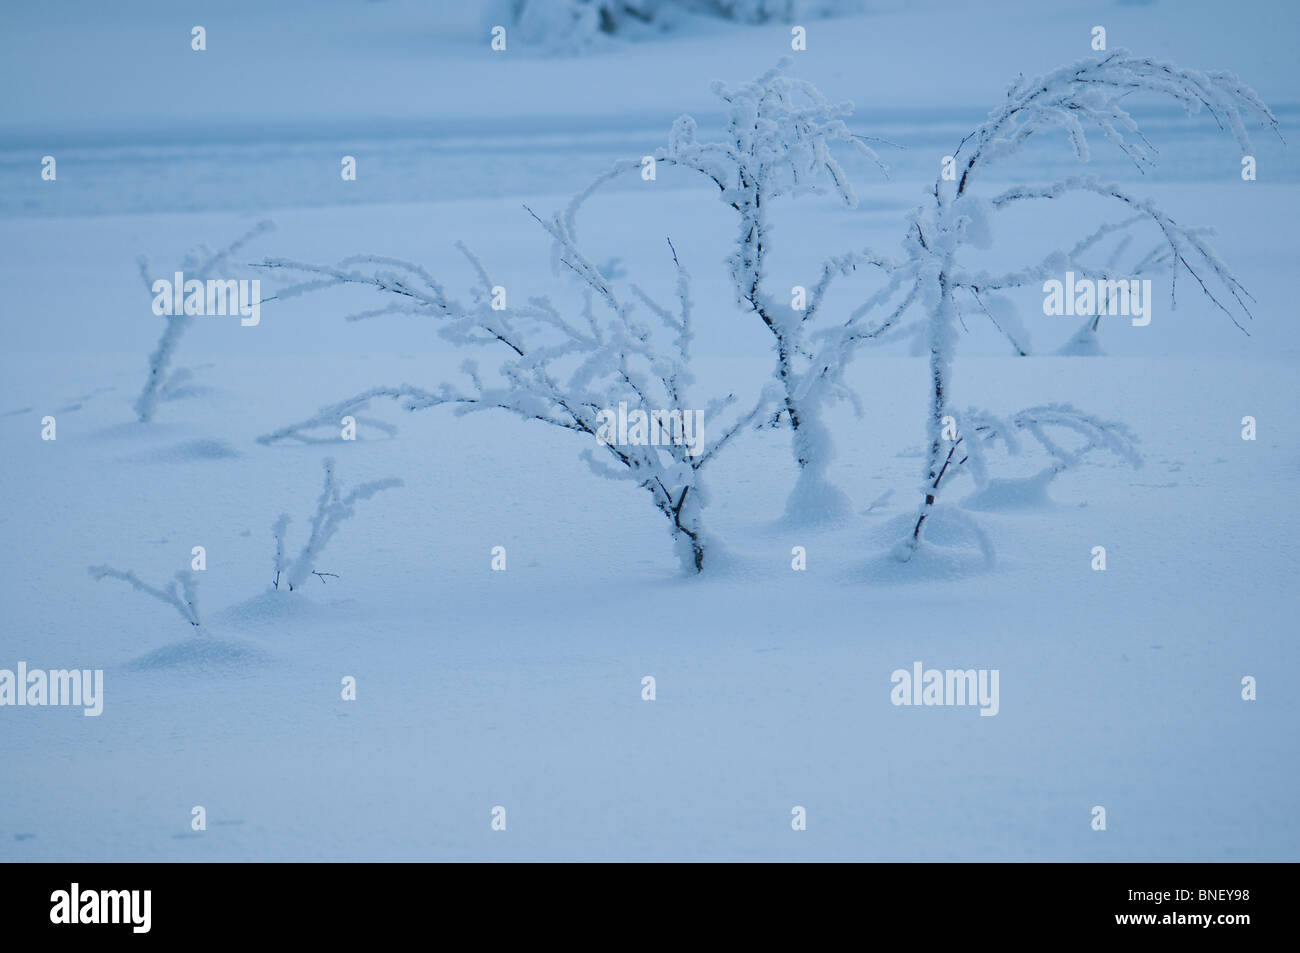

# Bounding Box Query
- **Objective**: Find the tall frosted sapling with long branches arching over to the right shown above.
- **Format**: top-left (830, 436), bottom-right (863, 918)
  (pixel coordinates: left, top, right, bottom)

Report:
top-left (897, 49), bottom-right (1278, 559)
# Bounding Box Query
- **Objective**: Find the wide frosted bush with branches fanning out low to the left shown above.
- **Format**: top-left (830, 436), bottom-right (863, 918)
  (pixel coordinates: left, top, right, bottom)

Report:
top-left (259, 216), bottom-right (771, 572)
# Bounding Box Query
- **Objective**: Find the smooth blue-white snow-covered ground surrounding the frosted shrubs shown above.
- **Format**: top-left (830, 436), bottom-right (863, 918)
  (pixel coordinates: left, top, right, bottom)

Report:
top-left (0, 0), bottom-right (1300, 861)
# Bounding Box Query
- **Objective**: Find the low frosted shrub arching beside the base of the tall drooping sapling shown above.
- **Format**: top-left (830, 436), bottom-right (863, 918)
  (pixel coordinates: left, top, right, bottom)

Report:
top-left (939, 403), bottom-right (1143, 506)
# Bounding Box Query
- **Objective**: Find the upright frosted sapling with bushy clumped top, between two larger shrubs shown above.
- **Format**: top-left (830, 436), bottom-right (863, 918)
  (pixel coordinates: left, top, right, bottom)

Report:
top-left (564, 57), bottom-right (905, 519)
